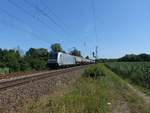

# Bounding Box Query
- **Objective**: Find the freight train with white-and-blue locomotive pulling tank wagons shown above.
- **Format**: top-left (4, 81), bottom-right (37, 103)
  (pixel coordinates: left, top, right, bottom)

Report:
top-left (48, 52), bottom-right (95, 67)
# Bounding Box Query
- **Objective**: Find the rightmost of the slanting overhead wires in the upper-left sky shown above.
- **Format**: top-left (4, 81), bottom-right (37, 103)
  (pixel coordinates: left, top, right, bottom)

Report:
top-left (24, 0), bottom-right (66, 33)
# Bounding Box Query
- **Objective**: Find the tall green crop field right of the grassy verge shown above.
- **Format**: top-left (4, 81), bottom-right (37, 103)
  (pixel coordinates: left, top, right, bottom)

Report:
top-left (106, 62), bottom-right (150, 89)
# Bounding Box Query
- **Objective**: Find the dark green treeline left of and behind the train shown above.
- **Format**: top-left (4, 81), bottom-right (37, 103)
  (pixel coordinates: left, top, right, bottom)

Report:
top-left (0, 43), bottom-right (82, 72)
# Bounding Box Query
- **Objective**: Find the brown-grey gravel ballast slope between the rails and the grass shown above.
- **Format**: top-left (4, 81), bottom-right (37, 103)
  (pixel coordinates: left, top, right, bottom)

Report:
top-left (0, 67), bottom-right (86, 113)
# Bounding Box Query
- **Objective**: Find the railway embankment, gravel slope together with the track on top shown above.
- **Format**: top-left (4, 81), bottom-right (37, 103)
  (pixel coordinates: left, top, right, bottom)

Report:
top-left (0, 66), bottom-right (87, 113)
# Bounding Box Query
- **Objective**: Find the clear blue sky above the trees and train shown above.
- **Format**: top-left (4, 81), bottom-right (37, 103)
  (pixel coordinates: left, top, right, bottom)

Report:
top-left (0, 0), bottom-right (150, 58)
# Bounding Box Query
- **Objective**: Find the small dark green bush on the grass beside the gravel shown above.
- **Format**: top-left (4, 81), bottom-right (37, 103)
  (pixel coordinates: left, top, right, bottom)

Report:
top-left (83, 65), bottom-right (104, 78)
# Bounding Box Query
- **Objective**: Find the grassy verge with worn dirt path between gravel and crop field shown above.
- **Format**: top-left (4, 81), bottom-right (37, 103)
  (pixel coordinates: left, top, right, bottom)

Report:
top-left (26, 64), bottom-right (150, 113)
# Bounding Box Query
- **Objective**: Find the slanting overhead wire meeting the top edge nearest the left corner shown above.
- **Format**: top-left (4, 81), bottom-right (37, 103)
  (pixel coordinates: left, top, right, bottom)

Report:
top-left (7, 0), bottom-right (57, 33)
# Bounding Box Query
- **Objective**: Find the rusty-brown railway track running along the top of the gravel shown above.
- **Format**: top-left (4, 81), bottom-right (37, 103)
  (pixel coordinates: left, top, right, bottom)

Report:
top-left (0, 65), bottom-right (88, 91)
